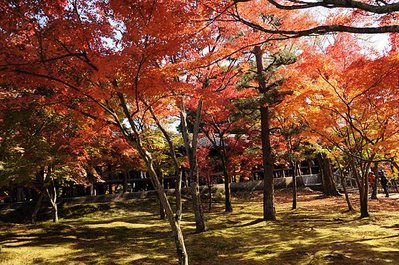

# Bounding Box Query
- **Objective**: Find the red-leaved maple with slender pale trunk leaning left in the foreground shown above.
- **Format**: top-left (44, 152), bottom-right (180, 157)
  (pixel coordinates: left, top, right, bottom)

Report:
top-left (0, 1), bottom-right (214, 264)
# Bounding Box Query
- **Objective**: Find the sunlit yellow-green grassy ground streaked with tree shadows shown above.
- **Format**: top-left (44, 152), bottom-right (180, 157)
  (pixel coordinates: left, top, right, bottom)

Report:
top-left (0, 191), bottom-right (399, 265)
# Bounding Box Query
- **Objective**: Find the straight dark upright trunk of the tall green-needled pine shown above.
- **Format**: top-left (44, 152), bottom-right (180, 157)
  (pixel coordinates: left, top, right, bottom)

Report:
top-left (254, 46), bottom-right (276, 220)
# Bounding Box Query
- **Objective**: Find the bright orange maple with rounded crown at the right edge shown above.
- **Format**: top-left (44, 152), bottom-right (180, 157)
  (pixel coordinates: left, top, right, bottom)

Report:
top-left (295, 35), bottom-right (398, 217)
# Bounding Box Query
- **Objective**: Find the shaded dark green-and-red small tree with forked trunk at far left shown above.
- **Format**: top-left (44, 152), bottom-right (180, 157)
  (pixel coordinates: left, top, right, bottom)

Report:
top-left (0, 102), bottom-right (88, 222)
